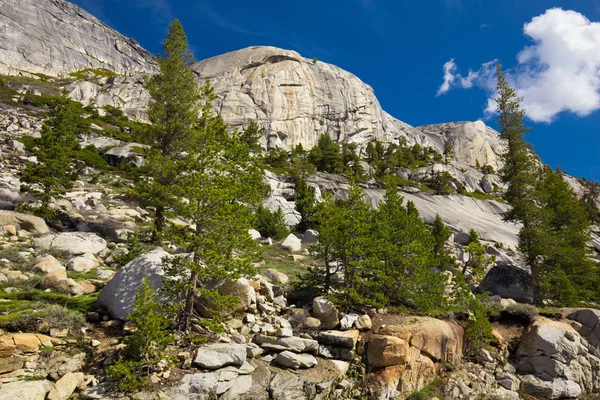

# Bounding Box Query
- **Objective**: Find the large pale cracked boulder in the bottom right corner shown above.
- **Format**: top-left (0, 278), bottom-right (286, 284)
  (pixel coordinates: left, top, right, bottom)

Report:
top-left (517, 317), bottom-right (600, 399)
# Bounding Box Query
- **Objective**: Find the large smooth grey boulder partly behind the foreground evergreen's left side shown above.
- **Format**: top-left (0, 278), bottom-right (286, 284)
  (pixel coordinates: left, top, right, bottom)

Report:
top-left (98, 248), bottom-right (170, 320)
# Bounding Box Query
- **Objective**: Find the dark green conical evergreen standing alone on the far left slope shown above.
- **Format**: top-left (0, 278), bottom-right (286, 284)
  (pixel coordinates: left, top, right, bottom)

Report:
top-left (22, 91), bottom-right (80, 217)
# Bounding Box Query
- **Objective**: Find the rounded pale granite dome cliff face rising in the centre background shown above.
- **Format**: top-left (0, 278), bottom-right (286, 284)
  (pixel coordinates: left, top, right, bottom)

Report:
top-left (194, 47), bottom-right (502, 168)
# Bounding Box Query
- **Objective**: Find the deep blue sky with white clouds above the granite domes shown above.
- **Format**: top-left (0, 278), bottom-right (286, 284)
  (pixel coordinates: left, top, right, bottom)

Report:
top-left (74, 0), bottom-right (600, 180)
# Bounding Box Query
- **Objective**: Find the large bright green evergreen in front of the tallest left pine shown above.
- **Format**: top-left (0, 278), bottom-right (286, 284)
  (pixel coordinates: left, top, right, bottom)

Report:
top-left (165, 82), bottom-right (263, 331)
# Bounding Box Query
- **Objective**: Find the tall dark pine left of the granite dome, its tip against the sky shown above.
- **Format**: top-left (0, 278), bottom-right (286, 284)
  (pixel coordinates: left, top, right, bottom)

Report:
top-left (131, 20), bottom-right (200, 235)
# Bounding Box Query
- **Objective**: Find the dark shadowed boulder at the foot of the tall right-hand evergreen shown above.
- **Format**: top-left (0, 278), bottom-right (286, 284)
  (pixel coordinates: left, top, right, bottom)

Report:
top-left (478, 264), bottom-right (533, 303)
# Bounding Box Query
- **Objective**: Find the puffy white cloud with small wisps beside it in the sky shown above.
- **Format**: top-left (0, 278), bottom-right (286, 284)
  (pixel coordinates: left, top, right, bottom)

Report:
top-left (438, 8), bottom-right (600, 123)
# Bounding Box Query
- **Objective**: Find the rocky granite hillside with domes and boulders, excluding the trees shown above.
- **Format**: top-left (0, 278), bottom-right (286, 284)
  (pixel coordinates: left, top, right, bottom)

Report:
top-left (0, 0), bottom-right (600, 400)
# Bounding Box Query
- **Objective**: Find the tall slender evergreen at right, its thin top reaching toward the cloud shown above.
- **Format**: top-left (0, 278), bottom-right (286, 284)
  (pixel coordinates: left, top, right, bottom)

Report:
top-left (496, 65), bottom-right (545, 303)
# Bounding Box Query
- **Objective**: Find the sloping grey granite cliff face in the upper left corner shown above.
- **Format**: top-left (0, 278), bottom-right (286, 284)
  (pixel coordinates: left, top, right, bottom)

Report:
top-left (0, 0), bottom-right (156, 77)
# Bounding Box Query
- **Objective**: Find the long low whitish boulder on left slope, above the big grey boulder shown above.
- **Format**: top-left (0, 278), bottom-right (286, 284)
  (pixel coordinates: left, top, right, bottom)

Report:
top-left (35, 232), bottom-right (106, 255)
